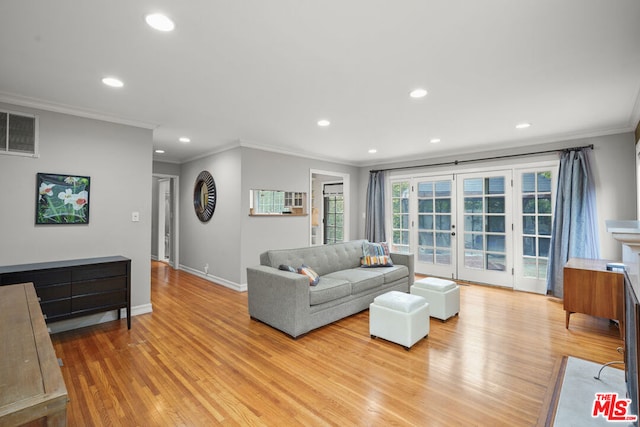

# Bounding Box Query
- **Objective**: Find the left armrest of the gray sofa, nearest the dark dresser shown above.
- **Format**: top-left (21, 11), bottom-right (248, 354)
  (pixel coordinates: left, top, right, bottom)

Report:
top-left (247, 265), bottom-right (309, 338)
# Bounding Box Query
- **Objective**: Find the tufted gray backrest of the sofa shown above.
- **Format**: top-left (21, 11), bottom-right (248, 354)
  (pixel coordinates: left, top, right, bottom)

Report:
top-left (260, 240), bottom-right (364, 276)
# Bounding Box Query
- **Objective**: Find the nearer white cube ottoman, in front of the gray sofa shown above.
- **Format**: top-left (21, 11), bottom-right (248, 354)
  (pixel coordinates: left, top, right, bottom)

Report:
top-left (369, 291), bottom-right (429, 350)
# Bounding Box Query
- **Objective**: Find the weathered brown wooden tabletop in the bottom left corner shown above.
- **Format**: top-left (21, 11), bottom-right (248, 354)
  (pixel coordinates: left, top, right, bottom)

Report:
top-left (0, 283), bottom-right (68, 426)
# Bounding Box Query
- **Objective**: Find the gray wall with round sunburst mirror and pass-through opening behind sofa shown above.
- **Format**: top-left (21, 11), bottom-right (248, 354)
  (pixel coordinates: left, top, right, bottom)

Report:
top-left (175, 147), bottom-right (359, 290)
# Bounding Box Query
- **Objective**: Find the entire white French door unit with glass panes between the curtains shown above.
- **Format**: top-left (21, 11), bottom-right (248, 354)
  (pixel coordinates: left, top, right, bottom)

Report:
top-left (389, 166), bottom-right (557, 294)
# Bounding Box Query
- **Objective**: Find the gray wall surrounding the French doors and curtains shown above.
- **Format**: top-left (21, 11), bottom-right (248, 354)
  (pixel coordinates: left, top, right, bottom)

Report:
top-left (356, 132), bottom-right (636, 260)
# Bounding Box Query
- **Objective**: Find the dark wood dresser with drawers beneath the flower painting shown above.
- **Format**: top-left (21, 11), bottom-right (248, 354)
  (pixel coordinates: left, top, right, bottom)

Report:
top-left (0, 256), bottom-right (131, 329)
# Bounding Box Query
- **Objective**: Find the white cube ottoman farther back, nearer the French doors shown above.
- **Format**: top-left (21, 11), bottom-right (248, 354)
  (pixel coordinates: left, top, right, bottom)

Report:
top-left (411, 277), bottom-right (460, 321)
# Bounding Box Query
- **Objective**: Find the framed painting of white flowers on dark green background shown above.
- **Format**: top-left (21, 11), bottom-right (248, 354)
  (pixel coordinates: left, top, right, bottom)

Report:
top-left (36, 173), bottom-right (91, 224)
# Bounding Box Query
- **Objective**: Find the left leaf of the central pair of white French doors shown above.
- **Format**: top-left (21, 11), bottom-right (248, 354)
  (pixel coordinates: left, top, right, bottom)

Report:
top-left (411, 175), bottom-right (456, 279)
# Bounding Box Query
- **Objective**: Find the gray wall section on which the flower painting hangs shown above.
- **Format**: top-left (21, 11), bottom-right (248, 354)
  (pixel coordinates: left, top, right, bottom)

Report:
top-left (0, 104), bottom-right (153, 332)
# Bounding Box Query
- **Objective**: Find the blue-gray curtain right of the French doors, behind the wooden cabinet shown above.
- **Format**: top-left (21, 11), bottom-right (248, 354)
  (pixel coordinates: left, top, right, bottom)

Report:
top-left (547, 148), bottom-right (600, 298)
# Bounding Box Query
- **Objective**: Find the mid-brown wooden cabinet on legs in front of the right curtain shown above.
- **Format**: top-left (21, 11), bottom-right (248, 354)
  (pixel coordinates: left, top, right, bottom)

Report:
top-left (563, 258), bottom-right (624, 338)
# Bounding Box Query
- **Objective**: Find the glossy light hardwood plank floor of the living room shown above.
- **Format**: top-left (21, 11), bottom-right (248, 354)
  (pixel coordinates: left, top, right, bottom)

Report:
top-left (52, 262), bottom-right (622, 426)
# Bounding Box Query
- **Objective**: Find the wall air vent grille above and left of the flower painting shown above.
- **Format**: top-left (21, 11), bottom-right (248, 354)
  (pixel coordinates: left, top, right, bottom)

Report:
top-left (0, 111), bottom-right (38, 157)
